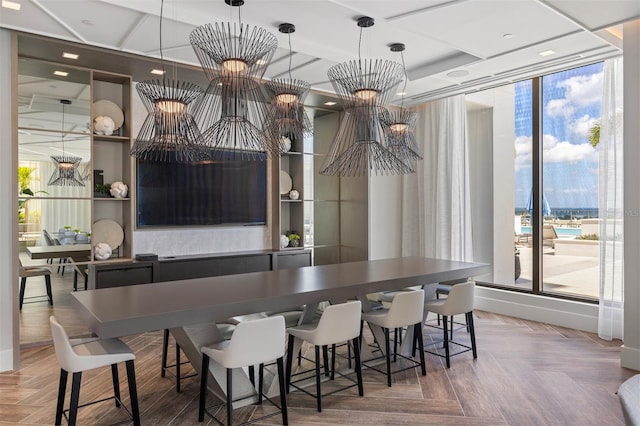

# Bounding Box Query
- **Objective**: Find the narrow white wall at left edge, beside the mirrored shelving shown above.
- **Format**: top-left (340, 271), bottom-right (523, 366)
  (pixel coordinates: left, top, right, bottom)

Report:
top-left (0, 28), bottom-right (20, 371)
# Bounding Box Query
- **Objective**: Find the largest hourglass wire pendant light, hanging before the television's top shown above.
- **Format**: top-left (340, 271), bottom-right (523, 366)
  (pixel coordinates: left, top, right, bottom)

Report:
top-left (189, 0), bottom-right (282, 160)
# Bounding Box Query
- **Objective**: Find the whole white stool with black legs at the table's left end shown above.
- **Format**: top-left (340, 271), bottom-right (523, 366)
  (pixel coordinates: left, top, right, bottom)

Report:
top-left (49, 316), bottom-right (140, 426)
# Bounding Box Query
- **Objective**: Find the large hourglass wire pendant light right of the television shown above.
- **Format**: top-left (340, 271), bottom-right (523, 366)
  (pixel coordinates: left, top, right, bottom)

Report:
top-left (320, 17), bottom-right (411, 176)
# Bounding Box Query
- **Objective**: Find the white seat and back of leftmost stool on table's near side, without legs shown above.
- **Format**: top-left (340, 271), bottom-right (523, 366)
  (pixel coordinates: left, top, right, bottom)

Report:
top-left (202, 316), bottom-right (285, 368)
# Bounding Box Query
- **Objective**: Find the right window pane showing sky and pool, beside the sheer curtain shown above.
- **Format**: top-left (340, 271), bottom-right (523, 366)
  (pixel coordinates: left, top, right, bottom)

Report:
top-left (542, 63), bottom-right (603, 299)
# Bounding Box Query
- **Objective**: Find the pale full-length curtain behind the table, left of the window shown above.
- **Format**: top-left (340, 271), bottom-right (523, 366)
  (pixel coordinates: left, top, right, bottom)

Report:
top-left (402, 95), bottom-right (473, 261)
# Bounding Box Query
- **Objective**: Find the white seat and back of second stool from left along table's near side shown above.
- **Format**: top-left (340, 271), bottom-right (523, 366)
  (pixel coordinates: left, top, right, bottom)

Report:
top-left (287, 300), bottom-right (362, 346)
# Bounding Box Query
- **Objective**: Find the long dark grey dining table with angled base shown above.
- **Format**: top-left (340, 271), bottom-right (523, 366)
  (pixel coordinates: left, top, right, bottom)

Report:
top-left (71, 257), bottom-right (490, 404)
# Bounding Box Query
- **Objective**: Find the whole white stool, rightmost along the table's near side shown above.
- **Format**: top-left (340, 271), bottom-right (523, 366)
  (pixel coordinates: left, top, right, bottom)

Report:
top-left (424, 281), bottom-right (478, 368)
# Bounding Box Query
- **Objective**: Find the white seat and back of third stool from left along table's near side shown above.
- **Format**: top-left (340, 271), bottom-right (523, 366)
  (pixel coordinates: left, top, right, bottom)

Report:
top-left (362, 290), bottom-right (424, 329)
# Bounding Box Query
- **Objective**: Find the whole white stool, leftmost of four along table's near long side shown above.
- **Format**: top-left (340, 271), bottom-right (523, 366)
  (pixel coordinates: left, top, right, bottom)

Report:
top-left (198, 316), bottom-right (288, 425)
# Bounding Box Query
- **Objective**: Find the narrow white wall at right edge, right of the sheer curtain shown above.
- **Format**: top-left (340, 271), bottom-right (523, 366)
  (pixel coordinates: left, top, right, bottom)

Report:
top-left (621, 20), bottom-right (640, 371)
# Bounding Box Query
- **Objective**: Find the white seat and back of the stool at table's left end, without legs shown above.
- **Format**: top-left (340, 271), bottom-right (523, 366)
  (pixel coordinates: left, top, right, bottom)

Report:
top-left (49, 316), bottom-right (136, 373)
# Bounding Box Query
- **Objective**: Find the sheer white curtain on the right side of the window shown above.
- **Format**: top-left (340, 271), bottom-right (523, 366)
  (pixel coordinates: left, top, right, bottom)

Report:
top-left (598, 58), bottom-right (624, 340)
